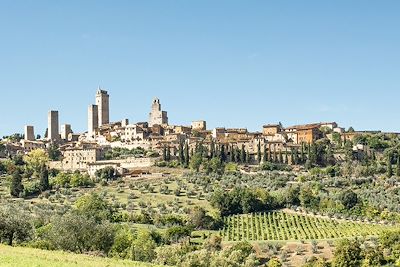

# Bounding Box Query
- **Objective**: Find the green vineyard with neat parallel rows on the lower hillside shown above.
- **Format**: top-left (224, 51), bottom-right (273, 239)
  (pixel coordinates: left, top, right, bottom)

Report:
top-left (221, 211), bottom-right (393, 242)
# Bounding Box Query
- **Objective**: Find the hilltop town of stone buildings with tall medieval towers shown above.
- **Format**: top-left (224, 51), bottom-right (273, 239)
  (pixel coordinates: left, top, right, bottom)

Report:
top-left (0, 87), bottom-right (384, 179)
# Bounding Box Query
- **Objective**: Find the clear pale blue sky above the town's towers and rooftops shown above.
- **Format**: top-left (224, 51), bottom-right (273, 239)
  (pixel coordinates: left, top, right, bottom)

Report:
top-left (0, 0), bottom-right (400, 136)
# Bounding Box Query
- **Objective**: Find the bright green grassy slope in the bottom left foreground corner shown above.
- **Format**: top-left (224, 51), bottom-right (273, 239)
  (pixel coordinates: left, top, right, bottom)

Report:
top-left (0, 245), bottom-right (161, 267)
